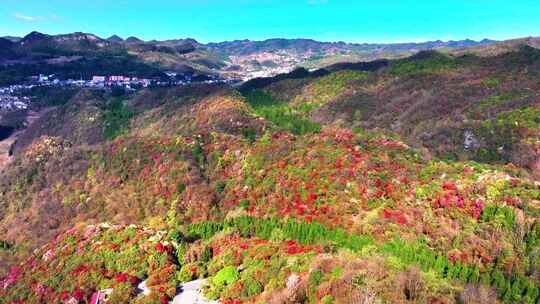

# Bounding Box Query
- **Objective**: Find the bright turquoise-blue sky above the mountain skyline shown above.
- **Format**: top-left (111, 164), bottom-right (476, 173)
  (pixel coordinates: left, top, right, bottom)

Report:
top-left (0, 0), bottom-right (540, 42)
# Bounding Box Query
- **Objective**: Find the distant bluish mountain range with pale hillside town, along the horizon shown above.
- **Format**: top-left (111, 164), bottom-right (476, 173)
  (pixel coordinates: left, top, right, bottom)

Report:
top-left (0, 32), bottom-right (536, 84)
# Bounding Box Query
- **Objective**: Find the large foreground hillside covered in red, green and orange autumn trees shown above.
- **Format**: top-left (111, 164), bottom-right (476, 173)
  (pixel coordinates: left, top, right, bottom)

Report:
top-left (0, 41), bottom-right (540, 304)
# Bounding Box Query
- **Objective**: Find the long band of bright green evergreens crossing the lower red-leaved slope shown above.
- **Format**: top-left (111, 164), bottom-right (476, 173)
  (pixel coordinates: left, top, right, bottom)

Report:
top-left (188, 217), bottom-right (540, 304)
